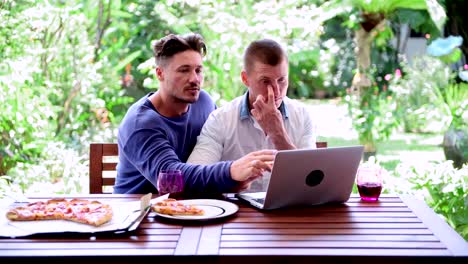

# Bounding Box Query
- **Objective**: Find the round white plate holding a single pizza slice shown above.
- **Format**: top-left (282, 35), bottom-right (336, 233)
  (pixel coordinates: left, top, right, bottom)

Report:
top-left (156, 199), bottom-right (239, 220)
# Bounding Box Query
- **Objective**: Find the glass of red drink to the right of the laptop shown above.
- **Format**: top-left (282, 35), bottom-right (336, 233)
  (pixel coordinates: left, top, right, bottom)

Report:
top-left (356, 164), bottom-right (382, 202)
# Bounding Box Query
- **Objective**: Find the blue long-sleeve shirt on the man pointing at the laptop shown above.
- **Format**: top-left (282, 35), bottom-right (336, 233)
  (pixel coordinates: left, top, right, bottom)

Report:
top-left (114, 91), bottom-right (237, 195)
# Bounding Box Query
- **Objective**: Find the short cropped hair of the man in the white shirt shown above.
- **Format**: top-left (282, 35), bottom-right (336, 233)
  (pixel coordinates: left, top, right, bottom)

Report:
top-left (244, 39), bottom-right (288, 72)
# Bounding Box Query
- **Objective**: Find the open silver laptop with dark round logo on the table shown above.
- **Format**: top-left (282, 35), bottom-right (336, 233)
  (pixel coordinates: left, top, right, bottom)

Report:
top-left (236, 145), bottom-right (364, 209)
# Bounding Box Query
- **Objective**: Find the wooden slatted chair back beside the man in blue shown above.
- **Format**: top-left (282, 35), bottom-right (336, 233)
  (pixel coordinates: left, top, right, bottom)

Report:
top-left (89, 143), bottom-right (119, 194)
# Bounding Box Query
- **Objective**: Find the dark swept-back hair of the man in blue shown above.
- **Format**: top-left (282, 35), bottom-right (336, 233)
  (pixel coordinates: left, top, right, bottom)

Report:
top-left (153, 33), bottom-right (206, 66)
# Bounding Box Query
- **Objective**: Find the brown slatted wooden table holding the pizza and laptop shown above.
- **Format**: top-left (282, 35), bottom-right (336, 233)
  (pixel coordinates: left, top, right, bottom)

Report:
top-left (0, 195), bottom-right (468, 264)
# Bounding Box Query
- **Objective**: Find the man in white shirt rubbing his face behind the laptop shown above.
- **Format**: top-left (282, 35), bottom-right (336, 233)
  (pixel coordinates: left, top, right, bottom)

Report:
top-left (187, 39), bottom-right (316, 190)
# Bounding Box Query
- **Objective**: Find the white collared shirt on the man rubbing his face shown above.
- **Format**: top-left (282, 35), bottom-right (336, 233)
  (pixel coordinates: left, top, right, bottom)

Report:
top-left (187, 93), bottom-right (316, 164)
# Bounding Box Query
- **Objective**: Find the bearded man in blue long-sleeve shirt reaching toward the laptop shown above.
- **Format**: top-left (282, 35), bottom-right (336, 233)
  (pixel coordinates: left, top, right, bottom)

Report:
top-left (114, 34), bottom-right (275, 195)
